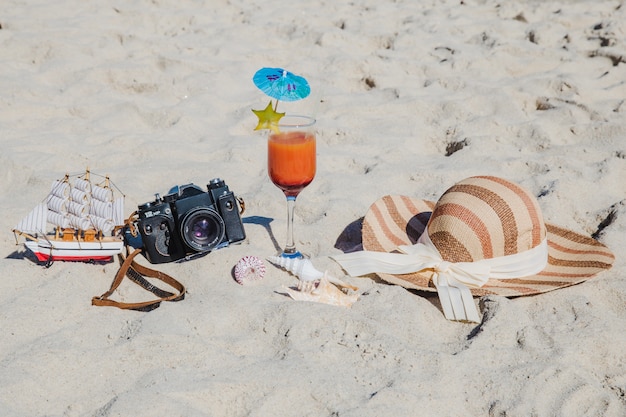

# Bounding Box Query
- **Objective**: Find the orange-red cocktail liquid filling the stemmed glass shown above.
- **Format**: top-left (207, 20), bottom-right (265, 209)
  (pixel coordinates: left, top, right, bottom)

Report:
top-left (267, 131), bottom-right (316, 197)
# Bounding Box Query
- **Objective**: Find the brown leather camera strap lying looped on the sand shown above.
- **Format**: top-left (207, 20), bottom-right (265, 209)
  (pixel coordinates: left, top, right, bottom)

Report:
top-left (91, 249), bottom-right (186, 311)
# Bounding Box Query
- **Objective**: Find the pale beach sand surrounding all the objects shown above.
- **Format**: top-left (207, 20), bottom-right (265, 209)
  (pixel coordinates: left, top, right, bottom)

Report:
top-left (0, 0), bottom-right (626, 417)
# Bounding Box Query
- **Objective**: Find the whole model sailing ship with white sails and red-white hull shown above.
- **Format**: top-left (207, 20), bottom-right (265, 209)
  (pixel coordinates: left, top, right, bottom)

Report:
top-left (13, 170), bottom-right (124, 262)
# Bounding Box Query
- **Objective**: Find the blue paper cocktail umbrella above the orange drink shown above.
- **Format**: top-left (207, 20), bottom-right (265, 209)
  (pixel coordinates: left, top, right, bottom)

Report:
top-left (252, 68), bottom-right (311, 101)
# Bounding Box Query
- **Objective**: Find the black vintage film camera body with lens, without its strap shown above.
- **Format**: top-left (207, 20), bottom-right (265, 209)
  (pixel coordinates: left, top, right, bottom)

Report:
top-left (137, 178), bottom-right (246, 264)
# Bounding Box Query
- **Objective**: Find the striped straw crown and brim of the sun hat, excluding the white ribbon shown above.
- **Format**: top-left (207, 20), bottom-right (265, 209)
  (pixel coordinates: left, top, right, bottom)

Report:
top-left (354, 176), bottom-right (614, 297)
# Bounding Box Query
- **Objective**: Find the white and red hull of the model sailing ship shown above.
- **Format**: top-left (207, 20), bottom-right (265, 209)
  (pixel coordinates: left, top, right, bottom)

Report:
top-left (24, 239), bottom-right (124, 262)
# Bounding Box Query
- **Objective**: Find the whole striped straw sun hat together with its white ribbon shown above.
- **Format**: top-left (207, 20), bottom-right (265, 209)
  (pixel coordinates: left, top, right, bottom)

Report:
top-left (333, 176), bottom-right (614, 321)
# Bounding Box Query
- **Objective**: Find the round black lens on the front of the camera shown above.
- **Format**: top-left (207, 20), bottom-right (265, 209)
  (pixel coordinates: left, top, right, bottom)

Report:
top-left (180, 207), bottom-right (225, 252)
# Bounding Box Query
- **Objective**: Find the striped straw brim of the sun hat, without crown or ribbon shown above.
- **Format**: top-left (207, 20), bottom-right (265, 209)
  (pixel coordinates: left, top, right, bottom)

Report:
top-left (362, 195), bottom-right (615, 297)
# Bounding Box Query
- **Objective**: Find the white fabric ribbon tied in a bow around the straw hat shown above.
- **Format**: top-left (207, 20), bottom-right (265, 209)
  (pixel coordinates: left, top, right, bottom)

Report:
top-left (332, 233), bottom-right (548, 323)
